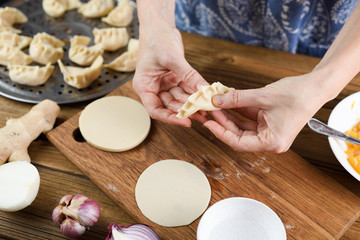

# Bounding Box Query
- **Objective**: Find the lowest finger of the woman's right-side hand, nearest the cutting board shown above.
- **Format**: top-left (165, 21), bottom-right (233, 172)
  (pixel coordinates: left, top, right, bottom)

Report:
top-left (204, 120), bottom-right (266, 152)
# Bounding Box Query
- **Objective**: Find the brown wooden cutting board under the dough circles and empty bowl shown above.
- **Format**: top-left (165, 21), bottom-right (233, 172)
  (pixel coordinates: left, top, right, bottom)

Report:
top-left (47, 82), bottom-right (360, 240)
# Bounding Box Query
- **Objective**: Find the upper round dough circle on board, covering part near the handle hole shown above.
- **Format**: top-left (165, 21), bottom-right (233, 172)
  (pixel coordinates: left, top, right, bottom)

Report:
top-left (79, 96), bottom-right (151, 152)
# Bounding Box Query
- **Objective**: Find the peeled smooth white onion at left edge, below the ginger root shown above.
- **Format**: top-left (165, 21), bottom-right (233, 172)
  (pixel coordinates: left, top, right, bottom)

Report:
top-left (0, 161), bottom-right (40, 212)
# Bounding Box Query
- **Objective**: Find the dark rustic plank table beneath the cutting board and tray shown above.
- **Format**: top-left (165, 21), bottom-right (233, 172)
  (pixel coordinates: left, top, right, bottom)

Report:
top-left (0, 33), bottom-right (360, 240)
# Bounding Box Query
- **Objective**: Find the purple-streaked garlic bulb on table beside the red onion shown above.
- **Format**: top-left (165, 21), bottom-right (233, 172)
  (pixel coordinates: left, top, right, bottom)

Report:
top-left (52, 194), bottom-right (100, 238)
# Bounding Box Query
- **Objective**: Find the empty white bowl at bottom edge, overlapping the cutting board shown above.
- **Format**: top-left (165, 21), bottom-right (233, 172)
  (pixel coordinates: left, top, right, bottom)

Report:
top-left (197, 197), bottom-right (286, 240)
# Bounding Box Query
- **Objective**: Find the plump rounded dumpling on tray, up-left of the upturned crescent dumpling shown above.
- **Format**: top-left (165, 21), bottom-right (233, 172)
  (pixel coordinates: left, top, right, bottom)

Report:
top-left (29, 32), bottom-right (65, 64)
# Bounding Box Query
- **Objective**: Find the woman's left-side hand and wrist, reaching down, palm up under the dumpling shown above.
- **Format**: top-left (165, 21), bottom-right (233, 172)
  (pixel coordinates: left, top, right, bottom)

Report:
top-left (133, 0), bottom-right (208, 127)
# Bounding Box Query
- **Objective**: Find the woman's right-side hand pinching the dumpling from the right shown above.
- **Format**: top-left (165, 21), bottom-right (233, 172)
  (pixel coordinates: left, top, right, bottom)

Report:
top-left (204, 73), bottom-right (328, 153)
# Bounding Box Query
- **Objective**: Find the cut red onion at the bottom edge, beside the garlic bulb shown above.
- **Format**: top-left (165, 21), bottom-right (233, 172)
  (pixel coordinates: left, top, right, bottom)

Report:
top-left (106, 223), bottom-right (161, 240)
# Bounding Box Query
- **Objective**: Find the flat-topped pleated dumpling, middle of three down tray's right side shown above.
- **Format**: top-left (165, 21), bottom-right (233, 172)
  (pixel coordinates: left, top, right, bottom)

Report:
top-left (93, 28), bottom-right (129, 51)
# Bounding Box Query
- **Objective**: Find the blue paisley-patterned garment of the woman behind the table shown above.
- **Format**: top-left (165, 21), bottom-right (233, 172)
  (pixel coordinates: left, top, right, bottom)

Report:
top-left (175, 0), bottom-right (358, 57)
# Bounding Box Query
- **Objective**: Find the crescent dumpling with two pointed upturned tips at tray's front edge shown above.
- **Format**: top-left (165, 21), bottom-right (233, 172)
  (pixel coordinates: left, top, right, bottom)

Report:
top-left (58, 56), bottom-right (104, 88)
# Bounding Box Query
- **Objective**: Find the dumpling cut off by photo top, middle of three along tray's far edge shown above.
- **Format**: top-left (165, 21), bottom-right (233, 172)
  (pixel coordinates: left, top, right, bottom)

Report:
top-left (78, 0), bottom-right (114, 18)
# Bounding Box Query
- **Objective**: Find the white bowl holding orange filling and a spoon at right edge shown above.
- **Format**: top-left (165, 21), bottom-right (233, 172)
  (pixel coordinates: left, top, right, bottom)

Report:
top-left (328, 92), bottom-right (360, 181)
